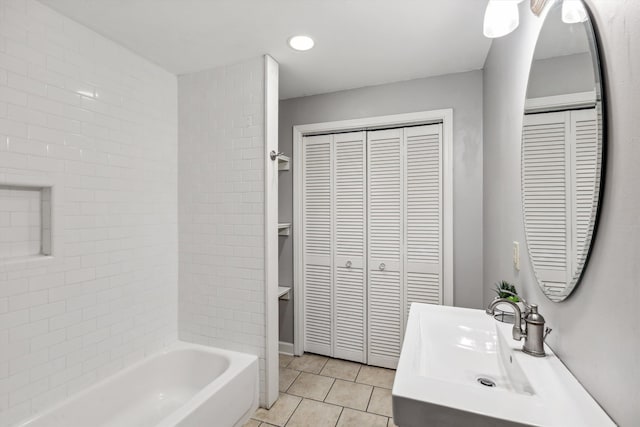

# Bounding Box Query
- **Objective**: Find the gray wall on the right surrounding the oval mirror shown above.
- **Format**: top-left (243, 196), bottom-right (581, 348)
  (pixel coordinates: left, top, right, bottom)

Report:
top-left (483, 0), bottom-right (640, 426)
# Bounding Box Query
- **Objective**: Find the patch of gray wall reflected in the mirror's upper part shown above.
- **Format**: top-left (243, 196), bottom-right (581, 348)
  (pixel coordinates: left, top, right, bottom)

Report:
top-left (527, 53), bottom-right (594, 98)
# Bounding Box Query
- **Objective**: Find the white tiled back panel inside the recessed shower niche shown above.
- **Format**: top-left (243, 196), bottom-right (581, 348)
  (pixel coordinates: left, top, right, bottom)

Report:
top-left (0, 184), bottom-right (42, 262)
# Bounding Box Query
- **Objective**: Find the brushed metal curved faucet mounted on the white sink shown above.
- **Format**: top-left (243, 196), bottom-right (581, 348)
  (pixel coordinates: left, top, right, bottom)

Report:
top-left (486, 298), bottom-right (551, 357)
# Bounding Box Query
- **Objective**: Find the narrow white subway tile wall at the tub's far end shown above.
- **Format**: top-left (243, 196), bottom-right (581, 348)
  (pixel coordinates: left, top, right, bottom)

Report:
top-left (178, 57), bottom-right (265, 402)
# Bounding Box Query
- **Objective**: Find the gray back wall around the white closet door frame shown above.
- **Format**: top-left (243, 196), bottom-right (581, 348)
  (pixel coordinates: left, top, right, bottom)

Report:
top-left (279, 71), bottom-right (482, 342)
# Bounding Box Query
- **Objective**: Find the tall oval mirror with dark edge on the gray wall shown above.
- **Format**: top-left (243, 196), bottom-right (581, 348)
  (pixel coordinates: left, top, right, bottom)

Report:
top-left (521, 0), bottom-right (604, 301)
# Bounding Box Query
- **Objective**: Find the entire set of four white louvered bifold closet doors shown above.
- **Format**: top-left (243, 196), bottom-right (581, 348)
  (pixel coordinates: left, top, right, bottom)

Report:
top-left (302, 124), bottom-right (443, 368)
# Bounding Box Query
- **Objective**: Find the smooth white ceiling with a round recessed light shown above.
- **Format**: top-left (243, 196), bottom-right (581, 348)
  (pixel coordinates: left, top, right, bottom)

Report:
top-left (41, 0), bottom-right (491, 99)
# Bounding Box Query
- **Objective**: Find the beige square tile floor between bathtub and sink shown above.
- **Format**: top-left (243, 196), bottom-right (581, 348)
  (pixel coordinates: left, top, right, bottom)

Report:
top-left (244, 353), bottom-right (396, 427)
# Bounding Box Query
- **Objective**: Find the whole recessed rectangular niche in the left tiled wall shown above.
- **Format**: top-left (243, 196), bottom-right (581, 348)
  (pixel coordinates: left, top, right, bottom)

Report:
top-left (0, 184), bottom-right (51, 261)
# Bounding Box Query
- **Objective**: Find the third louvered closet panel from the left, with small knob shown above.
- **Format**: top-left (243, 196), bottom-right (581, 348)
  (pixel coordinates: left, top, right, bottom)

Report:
top-left (367, 129), bottom-right (404, 368)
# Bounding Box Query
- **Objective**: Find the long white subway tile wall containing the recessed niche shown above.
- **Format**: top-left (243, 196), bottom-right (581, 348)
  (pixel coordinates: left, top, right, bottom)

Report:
top-left (0, 0), bottom-right (177, 427)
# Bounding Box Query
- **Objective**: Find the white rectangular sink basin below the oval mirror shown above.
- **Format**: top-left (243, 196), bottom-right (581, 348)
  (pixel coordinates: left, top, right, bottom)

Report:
top-left (392, 303), bottom-right (615, 427)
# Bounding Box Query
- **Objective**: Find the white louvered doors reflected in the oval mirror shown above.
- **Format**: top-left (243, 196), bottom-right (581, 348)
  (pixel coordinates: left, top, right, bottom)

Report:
top-left (522, 108), bottom-right (601, 299)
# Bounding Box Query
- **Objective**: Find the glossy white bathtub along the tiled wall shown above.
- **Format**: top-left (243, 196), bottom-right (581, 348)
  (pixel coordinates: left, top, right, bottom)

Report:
top-left (20, 342), bottom-right (258, 427)
